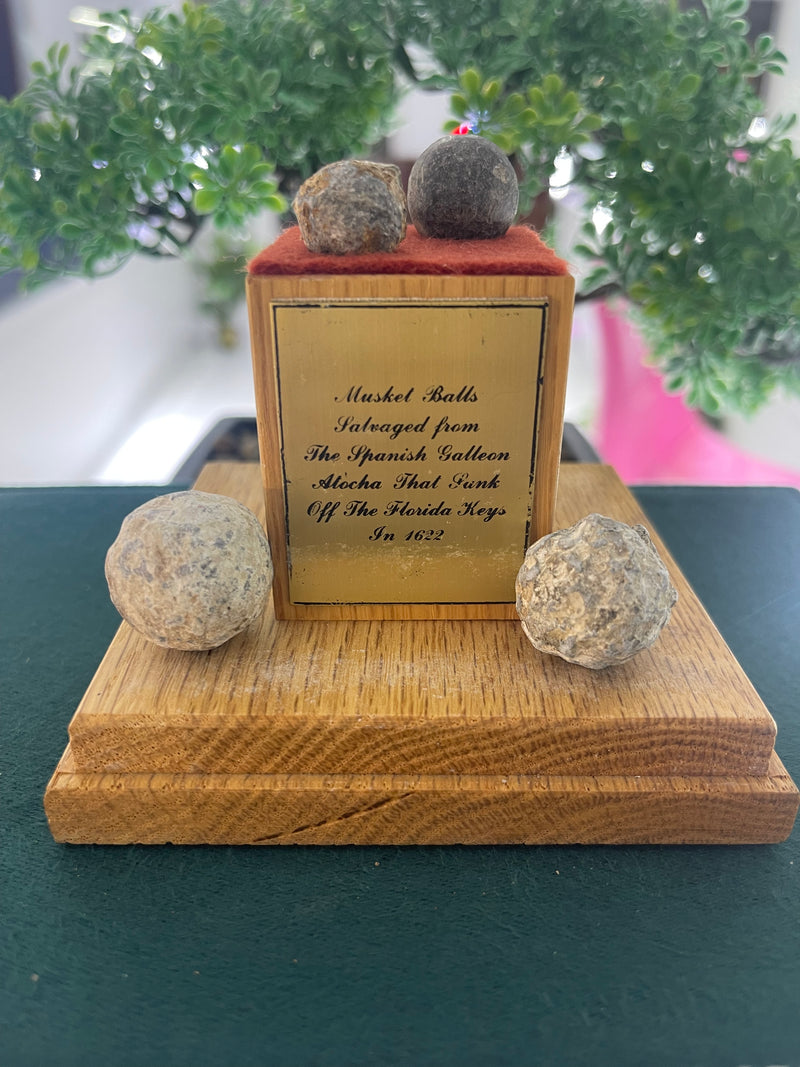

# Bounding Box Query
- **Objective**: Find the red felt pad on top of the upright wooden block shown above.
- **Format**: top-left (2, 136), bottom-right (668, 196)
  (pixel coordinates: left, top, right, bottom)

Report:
top-left (247, 226), bottom-right (569, 275)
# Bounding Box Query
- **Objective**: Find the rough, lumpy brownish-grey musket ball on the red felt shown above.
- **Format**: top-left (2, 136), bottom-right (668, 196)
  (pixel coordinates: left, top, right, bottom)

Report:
top-left (292, 159), bottom-right (406, 256)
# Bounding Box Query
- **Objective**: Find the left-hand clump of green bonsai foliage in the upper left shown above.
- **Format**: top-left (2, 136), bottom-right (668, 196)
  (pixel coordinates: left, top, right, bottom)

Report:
top-left (0, 0), bottom-right (396, 283)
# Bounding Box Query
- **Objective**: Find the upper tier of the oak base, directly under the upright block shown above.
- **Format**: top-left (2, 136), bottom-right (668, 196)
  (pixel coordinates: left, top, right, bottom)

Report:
top-left (64, 464), bottom-right (775, 775)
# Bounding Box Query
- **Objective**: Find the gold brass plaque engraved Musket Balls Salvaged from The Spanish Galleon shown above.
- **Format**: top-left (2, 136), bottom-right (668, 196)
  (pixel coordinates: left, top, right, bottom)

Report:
top-left (272, 299), bottom-right (547, 604)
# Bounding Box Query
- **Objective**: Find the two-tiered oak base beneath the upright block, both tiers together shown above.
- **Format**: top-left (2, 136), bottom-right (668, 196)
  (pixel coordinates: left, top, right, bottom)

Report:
top-left (45, 464), bottom-right (800, 844)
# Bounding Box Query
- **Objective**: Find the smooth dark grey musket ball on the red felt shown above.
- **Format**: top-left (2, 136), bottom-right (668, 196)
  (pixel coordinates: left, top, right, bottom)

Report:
top-left (409, 133), bottom-right (519, 240)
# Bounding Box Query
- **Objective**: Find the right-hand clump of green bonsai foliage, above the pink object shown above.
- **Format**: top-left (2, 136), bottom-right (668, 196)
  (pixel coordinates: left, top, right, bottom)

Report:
top-left (430, 0), bottom-right (800, 414)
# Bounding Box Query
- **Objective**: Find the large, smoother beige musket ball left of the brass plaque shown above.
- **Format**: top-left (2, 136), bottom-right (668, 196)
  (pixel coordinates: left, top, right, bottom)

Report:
top-left (106, 490), bottom-right (273, 652)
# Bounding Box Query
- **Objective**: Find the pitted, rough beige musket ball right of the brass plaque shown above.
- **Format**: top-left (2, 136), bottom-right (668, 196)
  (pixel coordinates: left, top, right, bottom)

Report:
top-left (516, 514), bottom-right (677, 669)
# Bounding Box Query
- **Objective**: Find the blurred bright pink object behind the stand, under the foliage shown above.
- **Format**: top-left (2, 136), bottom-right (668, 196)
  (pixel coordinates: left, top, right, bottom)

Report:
top-left (594, 303), bottom-right (800, 489)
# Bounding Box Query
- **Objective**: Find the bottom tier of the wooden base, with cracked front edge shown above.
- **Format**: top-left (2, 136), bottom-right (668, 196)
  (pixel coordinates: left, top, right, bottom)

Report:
top-left (46, 749), bottom-right (798, 845)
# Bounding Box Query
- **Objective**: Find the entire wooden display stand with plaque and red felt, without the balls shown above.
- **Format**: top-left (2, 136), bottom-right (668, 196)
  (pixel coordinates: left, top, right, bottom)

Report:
top-left (45, 227), bottom-right (799, 844)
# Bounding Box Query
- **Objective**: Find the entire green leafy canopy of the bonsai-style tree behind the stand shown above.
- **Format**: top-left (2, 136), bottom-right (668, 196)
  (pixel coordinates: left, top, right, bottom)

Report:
top-left (0, 0), bottom-right (800, 414)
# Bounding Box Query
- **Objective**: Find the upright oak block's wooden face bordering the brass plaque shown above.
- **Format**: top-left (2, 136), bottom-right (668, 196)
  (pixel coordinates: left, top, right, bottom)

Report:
top-left (247, 274), bottom-right (575, 620)
